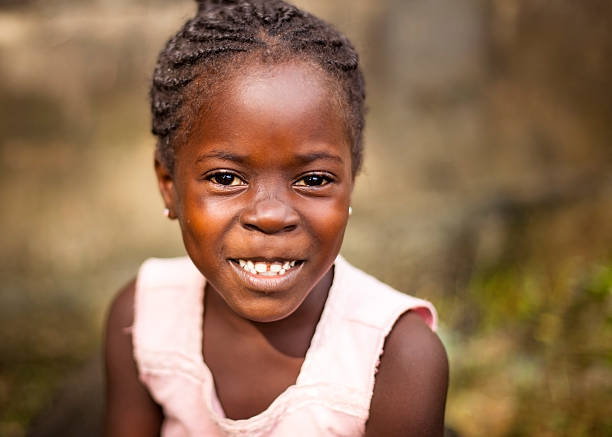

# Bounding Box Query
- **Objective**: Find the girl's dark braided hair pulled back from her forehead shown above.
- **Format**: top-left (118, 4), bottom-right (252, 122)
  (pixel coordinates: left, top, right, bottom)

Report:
top-left (151, 0), bottom-right (365, 175)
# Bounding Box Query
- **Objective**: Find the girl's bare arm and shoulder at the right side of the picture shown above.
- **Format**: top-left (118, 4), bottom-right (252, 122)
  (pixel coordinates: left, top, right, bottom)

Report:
top-left (366, 312), bottom-right (448, 437)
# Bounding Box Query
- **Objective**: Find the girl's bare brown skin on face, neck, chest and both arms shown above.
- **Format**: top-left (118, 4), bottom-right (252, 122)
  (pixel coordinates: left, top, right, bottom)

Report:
top-left (105, 61), bottom-right (448, 437)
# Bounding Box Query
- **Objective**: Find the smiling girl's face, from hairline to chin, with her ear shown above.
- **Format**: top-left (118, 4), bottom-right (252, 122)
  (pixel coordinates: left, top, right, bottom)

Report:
top-left (156, 62), bottom-right (353, 322)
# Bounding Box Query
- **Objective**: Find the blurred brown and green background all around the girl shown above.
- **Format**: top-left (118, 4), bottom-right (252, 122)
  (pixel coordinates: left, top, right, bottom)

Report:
top-left (0, 0), bottom-right (612, 437)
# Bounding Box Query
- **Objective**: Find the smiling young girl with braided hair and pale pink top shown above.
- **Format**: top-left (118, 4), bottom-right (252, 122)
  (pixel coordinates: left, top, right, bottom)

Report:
top-left (105, 0), bottom-right (448, 437)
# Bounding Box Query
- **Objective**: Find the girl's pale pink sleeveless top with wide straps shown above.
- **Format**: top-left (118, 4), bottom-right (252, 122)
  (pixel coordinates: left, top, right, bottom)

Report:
top-left (132, 256), bottom-right (436, 437)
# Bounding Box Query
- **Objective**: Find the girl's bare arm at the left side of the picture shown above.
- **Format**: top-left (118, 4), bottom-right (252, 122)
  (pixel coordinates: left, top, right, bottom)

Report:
top-left (104, 281), bottom-right (163, 437)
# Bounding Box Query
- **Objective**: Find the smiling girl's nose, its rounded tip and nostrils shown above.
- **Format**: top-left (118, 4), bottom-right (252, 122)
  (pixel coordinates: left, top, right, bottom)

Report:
top-left (240, 198), bottom-right (300, 234)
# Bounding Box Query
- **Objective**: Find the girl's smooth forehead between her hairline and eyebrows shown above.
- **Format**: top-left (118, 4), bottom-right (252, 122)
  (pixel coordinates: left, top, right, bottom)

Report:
top-left (187, 61), bottom-right (350, 157)
